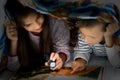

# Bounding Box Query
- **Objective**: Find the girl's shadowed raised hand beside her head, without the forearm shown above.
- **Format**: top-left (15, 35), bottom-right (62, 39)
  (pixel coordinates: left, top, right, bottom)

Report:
top-left (5, 21), bottom-right (18, 41)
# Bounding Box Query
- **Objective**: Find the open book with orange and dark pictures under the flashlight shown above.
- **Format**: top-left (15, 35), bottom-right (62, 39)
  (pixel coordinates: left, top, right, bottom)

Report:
top-left (10, 66), bottom-right (102, 80)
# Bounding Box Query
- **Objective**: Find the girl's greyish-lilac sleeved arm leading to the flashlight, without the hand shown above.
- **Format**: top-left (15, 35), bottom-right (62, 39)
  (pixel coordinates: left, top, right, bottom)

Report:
top-left (52, 20), bottom-right (70, 63)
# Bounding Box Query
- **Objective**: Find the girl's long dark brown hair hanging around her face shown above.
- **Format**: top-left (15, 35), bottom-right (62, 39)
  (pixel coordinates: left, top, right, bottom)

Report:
top-left (14, 7), bottom-right (52, 65)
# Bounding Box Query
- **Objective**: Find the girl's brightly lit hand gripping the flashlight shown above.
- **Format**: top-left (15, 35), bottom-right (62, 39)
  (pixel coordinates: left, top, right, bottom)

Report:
top-left (45, 52), bottom-right (64, 70)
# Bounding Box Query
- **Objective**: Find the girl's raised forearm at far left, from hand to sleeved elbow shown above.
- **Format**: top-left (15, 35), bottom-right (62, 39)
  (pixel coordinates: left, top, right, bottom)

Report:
top-left (5, 20), bottom-right (20, 71)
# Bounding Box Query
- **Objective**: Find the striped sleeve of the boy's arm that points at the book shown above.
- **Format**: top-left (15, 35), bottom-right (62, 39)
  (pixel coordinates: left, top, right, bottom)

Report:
top-left (74, 35), bottom-right (92, 62)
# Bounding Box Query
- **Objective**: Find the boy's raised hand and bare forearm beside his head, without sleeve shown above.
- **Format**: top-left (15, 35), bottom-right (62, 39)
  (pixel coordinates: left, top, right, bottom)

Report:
top-left (104, 23), bottom-right (120, 47)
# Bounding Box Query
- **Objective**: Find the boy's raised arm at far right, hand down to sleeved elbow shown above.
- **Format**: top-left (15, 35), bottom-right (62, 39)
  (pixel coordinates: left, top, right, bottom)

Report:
top-left (105, 23), bottom-right (120, 67)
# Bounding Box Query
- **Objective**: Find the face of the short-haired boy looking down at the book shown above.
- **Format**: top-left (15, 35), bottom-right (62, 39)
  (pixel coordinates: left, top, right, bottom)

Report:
top-left (79, 25), bottom-right (104, 45)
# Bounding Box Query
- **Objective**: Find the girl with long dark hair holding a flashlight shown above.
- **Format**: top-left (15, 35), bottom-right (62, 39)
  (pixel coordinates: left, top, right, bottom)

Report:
top-left (8, 7), bottom-right (70, 71)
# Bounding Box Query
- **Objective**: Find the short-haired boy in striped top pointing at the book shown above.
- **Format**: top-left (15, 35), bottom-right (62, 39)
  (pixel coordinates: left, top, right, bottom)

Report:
top-left (71, 13), bottom-right (120, 73)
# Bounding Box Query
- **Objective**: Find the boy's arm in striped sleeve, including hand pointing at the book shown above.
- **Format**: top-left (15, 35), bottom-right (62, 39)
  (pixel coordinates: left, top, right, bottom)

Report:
top-left (71, 36), bottom-right (92, 73)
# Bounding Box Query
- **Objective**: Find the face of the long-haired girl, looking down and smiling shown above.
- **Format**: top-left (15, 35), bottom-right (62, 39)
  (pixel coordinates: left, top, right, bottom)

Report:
top-left (23, 14), bottom-right (44, 33)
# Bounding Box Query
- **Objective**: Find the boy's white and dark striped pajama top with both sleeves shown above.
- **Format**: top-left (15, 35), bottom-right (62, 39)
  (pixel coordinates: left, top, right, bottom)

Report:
top-left (74, 34), bottom-right (120, 67)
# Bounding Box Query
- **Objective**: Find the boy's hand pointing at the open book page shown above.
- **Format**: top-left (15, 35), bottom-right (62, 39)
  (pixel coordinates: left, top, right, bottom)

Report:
top-left (71, 58), bottom-right (86, 73)
